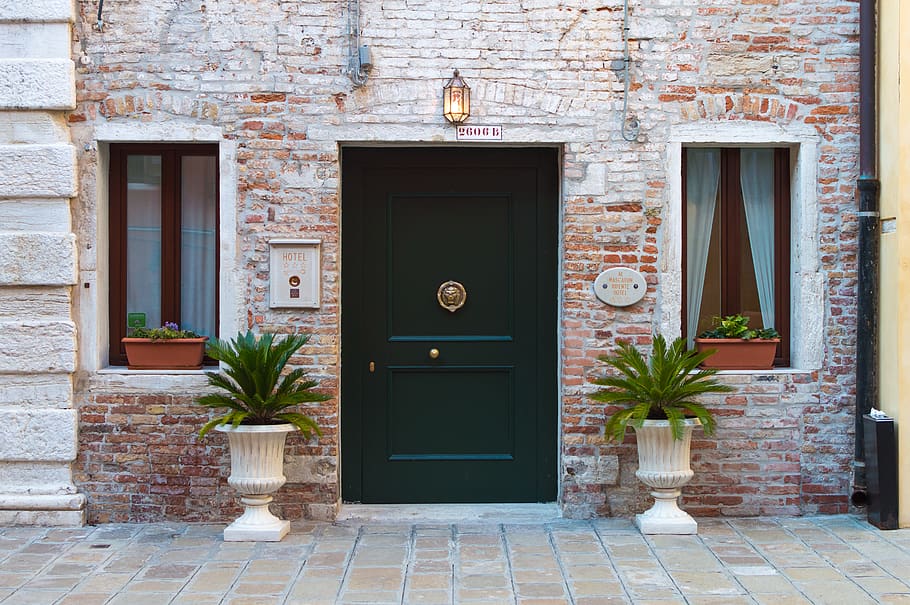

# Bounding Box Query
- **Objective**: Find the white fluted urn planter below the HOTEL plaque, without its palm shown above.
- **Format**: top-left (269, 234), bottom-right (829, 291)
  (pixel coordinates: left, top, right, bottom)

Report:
top-left (215, 424), bottom-right (297, 542)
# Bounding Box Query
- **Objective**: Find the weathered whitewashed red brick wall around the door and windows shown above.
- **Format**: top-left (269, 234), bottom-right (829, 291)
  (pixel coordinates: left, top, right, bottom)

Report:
top-left (67, 0), bottom-right (858, 520)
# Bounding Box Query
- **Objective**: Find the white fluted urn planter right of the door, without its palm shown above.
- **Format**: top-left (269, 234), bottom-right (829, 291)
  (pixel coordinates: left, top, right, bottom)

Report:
top-left (633, 418), bottom-right (701, 534)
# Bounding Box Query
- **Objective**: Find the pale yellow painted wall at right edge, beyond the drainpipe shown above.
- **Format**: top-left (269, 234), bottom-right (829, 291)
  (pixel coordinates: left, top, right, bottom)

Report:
top-left (878, 0), bottom-right (910, 527)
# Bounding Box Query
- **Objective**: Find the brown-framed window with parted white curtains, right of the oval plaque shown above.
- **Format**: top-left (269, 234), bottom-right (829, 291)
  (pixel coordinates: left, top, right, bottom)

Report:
top-left (682, 147), bottom-right (790, 365)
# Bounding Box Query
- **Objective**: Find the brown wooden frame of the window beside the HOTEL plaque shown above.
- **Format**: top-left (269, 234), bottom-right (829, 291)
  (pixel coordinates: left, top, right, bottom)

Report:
top-left (108, 143), bottom-right (221, 366)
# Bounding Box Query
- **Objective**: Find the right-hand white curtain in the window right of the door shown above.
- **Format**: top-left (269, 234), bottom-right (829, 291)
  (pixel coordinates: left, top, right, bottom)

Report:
top-left (739, 149), bottom-right (774, 328)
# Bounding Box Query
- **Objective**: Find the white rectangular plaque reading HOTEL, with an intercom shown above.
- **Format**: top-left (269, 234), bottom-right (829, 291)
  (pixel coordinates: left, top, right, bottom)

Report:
top-left (269, 239), bottom-right (322, 309)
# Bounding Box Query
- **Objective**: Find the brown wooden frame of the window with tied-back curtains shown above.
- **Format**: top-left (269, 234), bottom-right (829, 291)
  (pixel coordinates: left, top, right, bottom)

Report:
top-left (680, 147), bottom-right (791, 367)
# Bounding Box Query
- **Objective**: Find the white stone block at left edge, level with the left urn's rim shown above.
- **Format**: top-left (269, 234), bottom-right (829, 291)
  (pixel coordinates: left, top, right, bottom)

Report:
top-left (0, 407), bottom-right (76, 462)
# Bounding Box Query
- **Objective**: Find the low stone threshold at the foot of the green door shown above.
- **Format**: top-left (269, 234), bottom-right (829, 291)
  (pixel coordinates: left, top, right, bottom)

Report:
top-left (335, 502), bottom-right (561, 524)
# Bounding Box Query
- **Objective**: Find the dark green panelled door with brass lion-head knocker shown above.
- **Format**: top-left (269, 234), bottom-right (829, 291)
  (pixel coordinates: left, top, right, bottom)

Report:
top-left (341, 148), bottom-right (558, 503)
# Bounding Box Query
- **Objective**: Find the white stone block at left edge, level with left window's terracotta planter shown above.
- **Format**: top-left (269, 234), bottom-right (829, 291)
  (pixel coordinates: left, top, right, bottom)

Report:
top-left (0, 320), bottom-right (76, 372)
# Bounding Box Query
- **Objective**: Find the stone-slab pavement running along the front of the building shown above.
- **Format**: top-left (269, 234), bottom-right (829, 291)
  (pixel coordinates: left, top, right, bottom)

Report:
top-left (0, 516), bottom-right (910, 605)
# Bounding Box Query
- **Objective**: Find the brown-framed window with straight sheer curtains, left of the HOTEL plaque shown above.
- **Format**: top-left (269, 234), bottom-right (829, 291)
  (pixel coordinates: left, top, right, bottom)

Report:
top-left (109, 144), bottom-right (218, 365)
